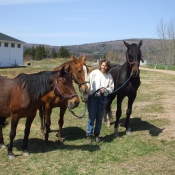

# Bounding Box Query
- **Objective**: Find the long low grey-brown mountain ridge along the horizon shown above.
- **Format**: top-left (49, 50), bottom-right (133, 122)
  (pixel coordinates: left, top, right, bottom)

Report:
top-left (24, 38), bottom-right (160, 56)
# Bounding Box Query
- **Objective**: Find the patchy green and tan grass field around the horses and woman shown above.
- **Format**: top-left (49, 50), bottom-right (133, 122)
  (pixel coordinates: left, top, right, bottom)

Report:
top-left (0, 60), bottom-right (175, 175)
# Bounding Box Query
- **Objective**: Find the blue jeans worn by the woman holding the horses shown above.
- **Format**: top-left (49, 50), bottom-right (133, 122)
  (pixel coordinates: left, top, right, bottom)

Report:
top-left (86, 96), bottom-right (107, 136)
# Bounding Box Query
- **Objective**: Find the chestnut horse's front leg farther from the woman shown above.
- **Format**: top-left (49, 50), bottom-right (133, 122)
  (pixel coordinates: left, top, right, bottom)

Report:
top-left (45, 106), bottom-right (52, 142)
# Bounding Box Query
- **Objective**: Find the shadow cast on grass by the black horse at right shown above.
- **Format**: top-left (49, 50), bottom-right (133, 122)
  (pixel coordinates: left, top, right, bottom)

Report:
top-left (111, 117), bottom-right (165, 136)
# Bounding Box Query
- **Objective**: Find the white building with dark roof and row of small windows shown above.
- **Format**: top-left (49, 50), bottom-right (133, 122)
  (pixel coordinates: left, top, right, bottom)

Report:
top-left (0, 33), bottom-right (24, 67)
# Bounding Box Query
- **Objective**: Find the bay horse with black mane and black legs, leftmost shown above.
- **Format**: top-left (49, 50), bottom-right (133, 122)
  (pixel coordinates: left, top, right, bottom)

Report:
top-left (0, 67), bottom-right (79, 159)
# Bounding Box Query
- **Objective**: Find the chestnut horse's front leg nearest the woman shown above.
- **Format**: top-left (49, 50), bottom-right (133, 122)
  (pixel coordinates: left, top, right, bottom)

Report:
top-left (58, 106), bottom-right (67, 143)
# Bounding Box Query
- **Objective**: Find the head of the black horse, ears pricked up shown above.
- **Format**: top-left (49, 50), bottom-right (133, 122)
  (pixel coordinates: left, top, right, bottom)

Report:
top-left (123, 40), bottom-right (143, 77)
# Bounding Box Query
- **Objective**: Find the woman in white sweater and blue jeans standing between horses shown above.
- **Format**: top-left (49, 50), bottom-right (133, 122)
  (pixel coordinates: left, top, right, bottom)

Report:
top-left (84, 59), bottom-right (114, 145)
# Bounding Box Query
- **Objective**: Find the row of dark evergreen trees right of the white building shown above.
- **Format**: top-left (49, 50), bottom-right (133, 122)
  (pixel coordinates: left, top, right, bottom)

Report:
top-left (23, 45), bottom-right (70, 60)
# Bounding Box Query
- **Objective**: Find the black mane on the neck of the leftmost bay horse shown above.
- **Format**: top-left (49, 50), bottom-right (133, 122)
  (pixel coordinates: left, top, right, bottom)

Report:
top-left (14, 71), bottom-right (58, 101)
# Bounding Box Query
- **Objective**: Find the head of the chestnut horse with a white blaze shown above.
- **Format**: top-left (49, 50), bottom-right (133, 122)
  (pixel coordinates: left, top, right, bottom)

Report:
top-left (73, 55), bottom-right (88, 92)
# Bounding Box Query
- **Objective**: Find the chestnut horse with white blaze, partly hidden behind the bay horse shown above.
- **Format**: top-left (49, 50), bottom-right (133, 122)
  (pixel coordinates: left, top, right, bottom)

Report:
top-left (39, 55), bottom-right (87, 142)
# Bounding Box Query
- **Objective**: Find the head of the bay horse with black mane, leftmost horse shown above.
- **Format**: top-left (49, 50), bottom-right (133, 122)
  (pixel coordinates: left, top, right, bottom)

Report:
top-left (54, 66), bottom-right (80, 109)
